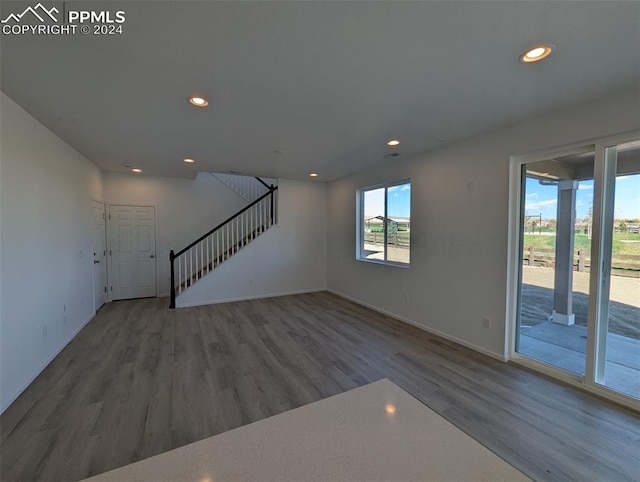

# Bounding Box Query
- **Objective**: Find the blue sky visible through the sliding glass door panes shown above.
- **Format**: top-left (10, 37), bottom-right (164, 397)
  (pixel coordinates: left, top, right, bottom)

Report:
top-left (525, 174), bottom-right (640, 219)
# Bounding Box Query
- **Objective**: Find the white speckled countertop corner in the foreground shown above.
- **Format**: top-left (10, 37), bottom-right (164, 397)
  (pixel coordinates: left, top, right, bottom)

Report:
top-left (81, 379), bottom-right (529, 482)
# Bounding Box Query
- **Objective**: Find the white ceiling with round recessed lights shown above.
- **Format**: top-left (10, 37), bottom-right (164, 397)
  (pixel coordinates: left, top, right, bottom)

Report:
top-left (0, 1), bottom-right (640, 181)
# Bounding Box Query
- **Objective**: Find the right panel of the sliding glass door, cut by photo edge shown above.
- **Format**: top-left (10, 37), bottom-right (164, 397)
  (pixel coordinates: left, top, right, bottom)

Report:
top-left (593, 141), bottom-right (640, 398)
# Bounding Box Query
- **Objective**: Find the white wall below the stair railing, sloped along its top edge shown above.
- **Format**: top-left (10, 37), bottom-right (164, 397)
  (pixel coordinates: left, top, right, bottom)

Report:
top-left (176, 179), bottom-right (327, 307)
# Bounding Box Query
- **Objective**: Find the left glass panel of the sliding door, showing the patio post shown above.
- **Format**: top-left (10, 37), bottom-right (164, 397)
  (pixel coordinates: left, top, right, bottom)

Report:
top-left (517, 150), bottom-right (594, 375)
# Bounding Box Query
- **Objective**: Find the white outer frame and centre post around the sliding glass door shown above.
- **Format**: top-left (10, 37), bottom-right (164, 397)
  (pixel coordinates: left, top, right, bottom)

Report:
top-left (504, 130), bottom-right (640, 410)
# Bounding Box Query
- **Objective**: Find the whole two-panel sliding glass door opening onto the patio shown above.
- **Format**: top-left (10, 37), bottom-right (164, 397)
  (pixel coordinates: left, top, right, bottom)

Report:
top-left (513, 135), bottom-right (640, 398)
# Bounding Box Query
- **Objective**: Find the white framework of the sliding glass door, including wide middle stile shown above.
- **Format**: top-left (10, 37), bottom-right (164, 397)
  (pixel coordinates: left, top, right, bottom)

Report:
top-left (504, 131), bottom-right (640, 411)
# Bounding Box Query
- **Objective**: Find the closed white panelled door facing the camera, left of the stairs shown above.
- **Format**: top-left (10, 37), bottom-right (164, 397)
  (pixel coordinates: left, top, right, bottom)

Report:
top-left (109, 205), bottom-right (156, 300)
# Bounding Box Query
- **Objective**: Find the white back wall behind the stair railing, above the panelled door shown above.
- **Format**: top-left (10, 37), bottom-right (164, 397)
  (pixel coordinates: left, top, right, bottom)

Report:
top-left (104, 172), bottom-right (247, 296)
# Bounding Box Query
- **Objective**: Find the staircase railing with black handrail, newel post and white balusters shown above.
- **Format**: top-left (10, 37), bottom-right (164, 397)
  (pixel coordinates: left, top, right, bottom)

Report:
top-left (169, 174), bottom-right (278, 308)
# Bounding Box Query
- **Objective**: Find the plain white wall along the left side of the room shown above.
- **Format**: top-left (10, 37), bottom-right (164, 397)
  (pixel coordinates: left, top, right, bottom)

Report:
top-left (0, 93), bottom-right (102, 411)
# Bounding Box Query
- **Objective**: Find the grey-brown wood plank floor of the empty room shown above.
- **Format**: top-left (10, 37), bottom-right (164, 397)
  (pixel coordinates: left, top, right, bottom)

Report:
top-left (0, 292), bottom-right (640, 481)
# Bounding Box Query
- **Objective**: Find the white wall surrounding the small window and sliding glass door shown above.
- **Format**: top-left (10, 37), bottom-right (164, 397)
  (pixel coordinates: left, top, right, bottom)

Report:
top-left (327, 90), bottom-right (640, 358)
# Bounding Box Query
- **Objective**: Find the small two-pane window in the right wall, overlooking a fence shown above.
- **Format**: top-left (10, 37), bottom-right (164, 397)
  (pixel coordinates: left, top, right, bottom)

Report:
top-left (356, 181), bottom-right (411, 266)
